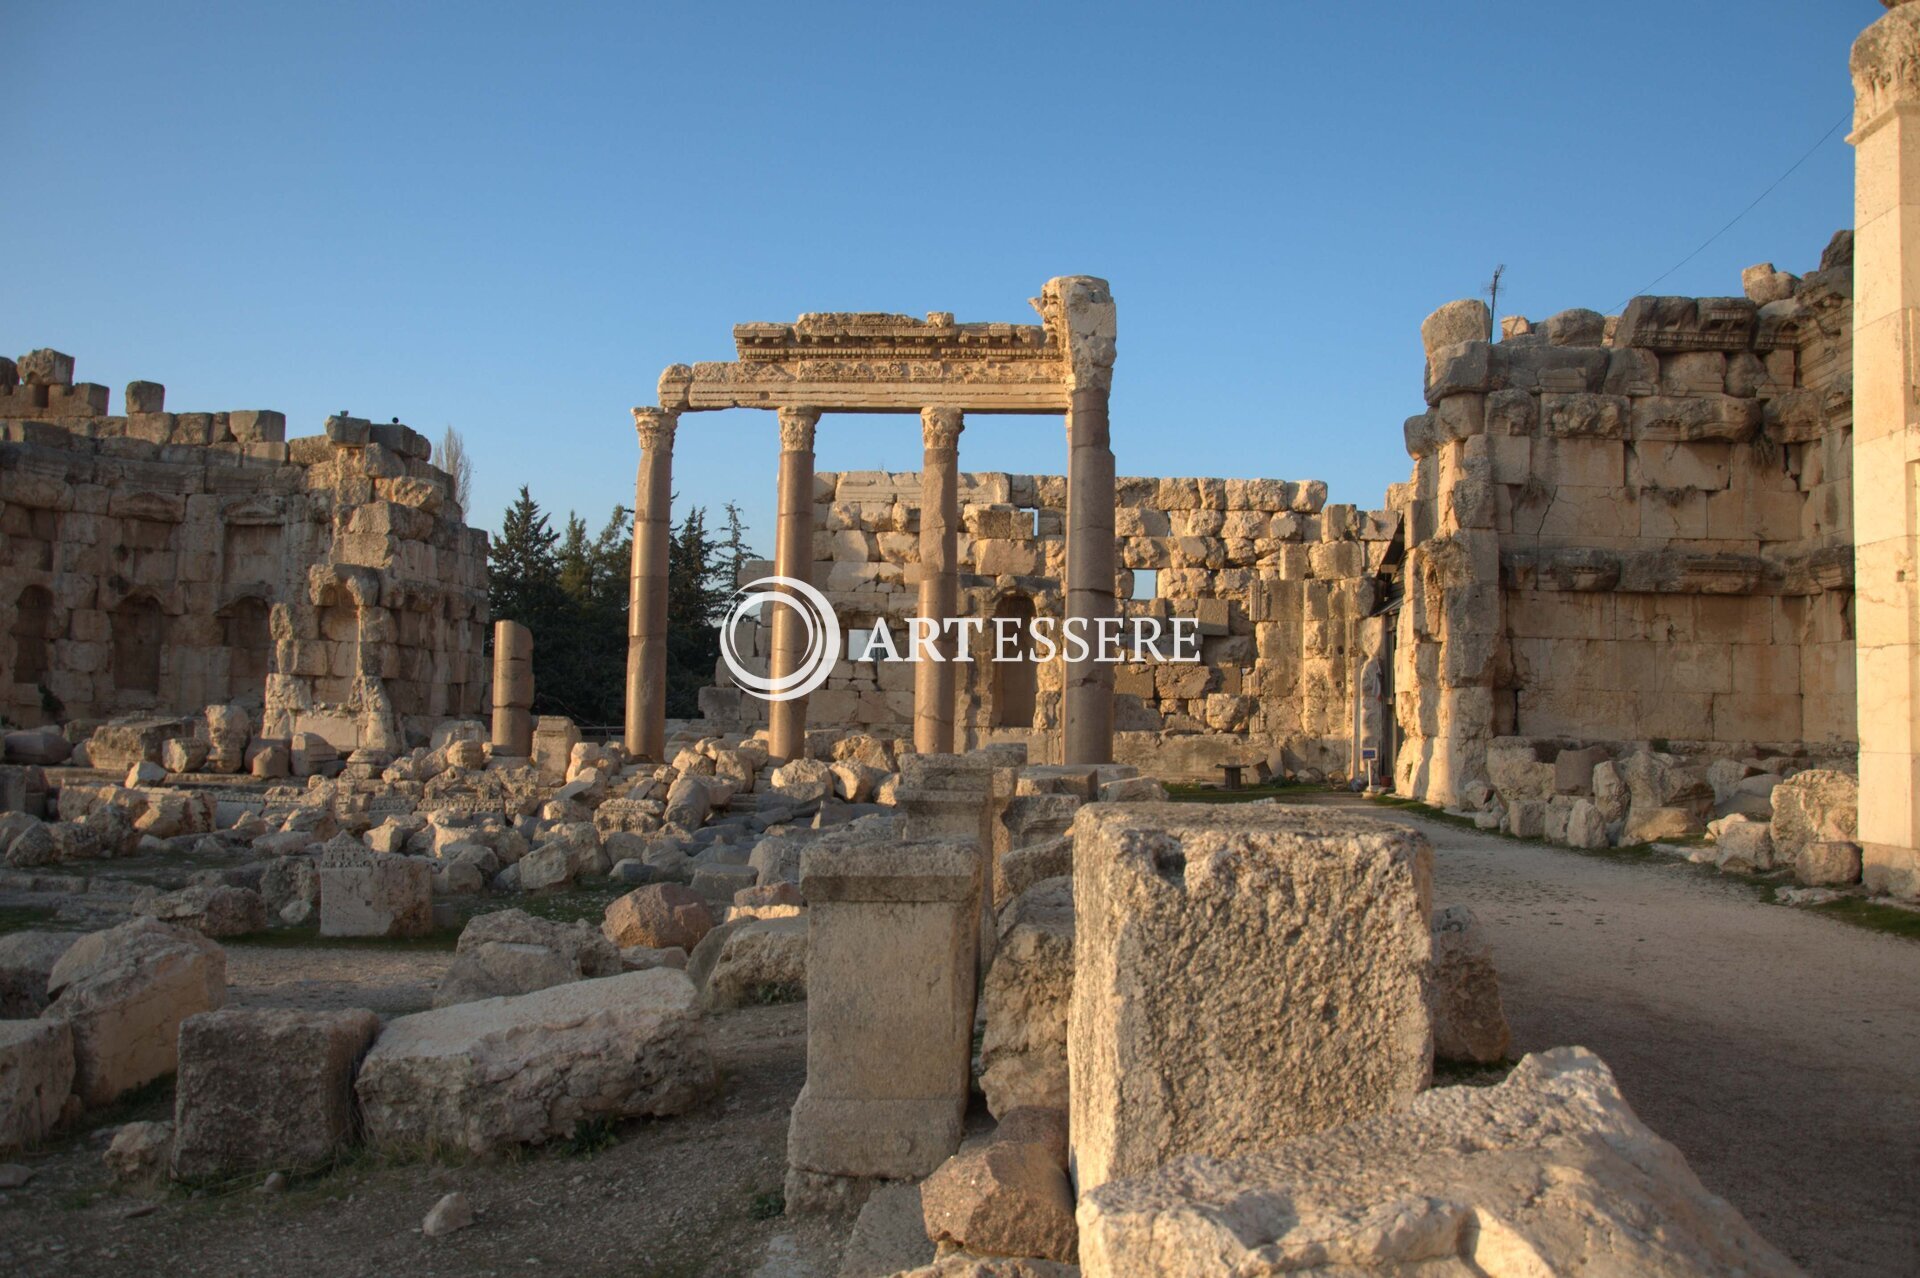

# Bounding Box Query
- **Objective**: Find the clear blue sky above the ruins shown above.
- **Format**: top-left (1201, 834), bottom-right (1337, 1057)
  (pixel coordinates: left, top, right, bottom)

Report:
top-left (0, 0), bottom-right (1858, 551)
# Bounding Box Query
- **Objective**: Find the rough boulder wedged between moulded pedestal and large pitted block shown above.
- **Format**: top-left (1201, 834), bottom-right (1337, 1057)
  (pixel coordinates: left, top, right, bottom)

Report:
top-left (979, 875), bottom-right (1073, 1119)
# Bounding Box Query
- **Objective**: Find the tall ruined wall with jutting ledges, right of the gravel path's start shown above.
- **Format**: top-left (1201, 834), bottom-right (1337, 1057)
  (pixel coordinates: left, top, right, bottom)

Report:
top-left (1388, 232), bottom-right (1855, 802)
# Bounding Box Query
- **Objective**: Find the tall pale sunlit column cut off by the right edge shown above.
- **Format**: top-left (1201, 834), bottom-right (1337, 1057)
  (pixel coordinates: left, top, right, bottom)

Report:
top-left (1847, 4), bottom-right (1920, 898)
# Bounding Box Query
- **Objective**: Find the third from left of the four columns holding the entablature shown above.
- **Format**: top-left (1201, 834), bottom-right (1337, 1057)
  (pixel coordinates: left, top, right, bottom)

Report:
top-left (914, 409), bottom-right (964, 754)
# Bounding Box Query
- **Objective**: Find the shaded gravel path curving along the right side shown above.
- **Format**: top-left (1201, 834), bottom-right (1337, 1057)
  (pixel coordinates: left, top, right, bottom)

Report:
top-left (1344, 806), bottom-right (1920, 1274)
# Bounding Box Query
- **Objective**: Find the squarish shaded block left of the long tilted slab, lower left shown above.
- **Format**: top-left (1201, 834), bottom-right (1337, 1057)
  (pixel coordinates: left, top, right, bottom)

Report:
top-left (173, 1007), bottom-right (380, 1180)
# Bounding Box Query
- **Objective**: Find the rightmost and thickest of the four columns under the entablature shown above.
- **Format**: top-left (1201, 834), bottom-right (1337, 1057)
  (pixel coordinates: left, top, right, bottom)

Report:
top-left (1041, 274), bottom-right (1116, 764)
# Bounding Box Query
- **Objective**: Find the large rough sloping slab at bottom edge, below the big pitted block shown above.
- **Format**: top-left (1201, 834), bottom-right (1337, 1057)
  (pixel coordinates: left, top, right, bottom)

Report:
top-left (1077, 1048), bottom-right (1799, 1278)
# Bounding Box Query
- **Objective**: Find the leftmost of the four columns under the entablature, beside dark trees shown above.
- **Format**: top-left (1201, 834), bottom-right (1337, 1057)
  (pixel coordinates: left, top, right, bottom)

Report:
top-left (626, 409), bottom-right (680, 764)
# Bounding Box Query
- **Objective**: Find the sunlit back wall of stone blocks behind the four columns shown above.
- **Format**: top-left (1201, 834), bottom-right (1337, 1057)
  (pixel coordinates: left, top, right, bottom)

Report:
top-left (703, 472), bottom-right (1398, 779)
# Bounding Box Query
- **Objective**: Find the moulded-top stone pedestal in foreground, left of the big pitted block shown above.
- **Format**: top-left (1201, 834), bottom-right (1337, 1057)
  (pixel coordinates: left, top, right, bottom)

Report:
top-left (787, 835), bottom-right (979, 1211)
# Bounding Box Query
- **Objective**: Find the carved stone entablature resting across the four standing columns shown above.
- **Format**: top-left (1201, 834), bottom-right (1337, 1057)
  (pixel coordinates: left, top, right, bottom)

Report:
top-left (660, 276), bottom-right (1114, 413)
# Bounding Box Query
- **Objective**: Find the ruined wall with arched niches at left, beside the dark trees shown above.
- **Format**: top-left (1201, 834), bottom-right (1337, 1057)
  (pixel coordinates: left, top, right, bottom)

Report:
top-left (0, 351), bottom-right (488, 748)
